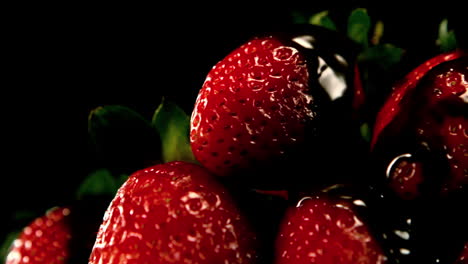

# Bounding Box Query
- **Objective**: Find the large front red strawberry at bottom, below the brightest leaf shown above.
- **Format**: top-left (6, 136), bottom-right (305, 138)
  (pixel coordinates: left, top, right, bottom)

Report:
top-left (89, 162), bottom-right (257, 264)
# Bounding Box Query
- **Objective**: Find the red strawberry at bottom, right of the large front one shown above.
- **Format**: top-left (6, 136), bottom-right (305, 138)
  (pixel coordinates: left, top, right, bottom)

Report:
top-left (275, 197), bottom-right (387, 264)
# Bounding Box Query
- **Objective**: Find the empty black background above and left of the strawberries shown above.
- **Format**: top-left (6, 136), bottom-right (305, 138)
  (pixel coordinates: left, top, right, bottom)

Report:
top-left (1, 1), bottom-right (465, 241)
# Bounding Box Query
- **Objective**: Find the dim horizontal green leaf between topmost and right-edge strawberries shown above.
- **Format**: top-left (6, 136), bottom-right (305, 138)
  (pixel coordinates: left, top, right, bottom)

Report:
top-left (358, 43), bottom-right (404, 69)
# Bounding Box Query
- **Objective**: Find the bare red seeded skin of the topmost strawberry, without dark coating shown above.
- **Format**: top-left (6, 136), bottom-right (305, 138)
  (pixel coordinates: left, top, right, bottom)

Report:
top-left (190, 37), bottom-right (315, 175)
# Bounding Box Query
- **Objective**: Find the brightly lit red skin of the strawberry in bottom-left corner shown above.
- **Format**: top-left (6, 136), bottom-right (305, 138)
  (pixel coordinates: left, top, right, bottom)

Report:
top-left (6, 207), bottom-right (72, 264)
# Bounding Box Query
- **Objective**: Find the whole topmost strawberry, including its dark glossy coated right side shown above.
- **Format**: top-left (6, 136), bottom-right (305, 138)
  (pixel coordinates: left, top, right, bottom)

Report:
top-left (190, 27), bottom-right (362, 186)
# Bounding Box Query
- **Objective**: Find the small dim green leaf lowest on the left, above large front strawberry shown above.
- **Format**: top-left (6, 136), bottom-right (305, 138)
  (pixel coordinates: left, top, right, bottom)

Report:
top-left (76, 169), bottom-right (120, 199)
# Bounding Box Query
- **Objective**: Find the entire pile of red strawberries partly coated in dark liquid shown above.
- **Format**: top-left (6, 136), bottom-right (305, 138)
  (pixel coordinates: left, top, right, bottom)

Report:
top-left (6, 21), bottom-right (468, 264)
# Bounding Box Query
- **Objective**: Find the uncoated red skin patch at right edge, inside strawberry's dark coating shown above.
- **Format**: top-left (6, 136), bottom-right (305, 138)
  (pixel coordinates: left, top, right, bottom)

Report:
top-left (421, 60), bottom-right (468, 192)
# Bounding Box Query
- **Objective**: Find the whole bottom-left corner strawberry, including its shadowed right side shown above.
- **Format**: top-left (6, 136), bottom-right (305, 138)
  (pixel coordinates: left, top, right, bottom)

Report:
top-left (6, 199), bottom-right (109, 264)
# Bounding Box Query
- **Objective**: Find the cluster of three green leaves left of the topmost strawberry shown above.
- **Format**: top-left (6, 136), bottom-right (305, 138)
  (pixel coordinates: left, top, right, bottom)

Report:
top-left (82, 98), bottom-right (196, 198)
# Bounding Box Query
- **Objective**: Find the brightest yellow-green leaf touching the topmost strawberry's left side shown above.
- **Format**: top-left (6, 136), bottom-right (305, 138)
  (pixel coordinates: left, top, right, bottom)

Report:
top-left (152, 98), bottom-right (195, 162)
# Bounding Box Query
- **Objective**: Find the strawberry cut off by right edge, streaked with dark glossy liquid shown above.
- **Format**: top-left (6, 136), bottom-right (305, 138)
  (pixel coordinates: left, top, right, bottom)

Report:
top-left (372, 51), bottom-right (468, 196)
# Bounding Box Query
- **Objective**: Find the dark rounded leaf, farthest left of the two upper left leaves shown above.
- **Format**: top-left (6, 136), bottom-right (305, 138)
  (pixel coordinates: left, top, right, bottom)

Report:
top-left (88, 105), bottom-right (161, 175)
